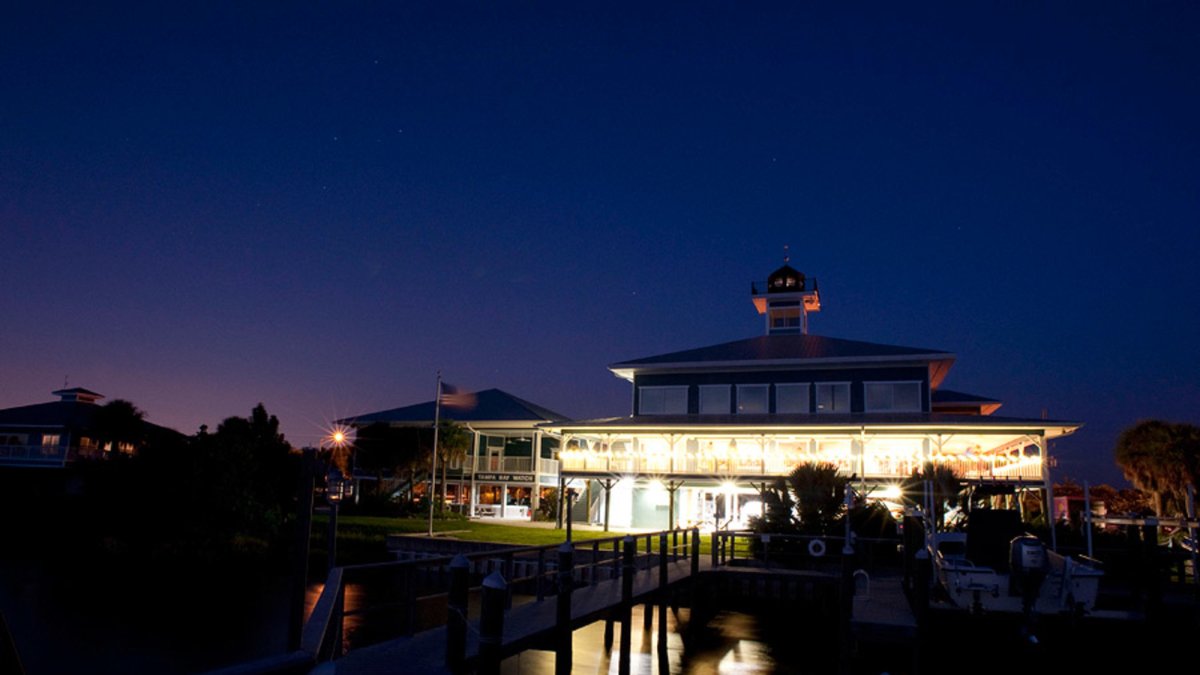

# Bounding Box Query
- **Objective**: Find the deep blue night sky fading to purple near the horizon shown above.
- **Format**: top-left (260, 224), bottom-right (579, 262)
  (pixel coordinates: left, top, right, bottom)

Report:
top-left (0, 1), bottom-right (1200, 480)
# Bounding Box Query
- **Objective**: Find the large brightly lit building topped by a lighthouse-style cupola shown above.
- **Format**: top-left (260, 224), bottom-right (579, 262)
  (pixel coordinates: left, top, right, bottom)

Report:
top-left (542, 262), bottom-right (1080, 528)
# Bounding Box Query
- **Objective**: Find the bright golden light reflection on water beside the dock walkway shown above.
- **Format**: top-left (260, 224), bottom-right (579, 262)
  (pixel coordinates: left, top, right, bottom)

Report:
top-left (502, 605), bottom-right (835, 675)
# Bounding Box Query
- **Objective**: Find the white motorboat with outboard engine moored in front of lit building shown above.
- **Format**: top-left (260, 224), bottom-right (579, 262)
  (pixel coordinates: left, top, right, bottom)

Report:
top-left (928, 509), bottom-right (1104, 615)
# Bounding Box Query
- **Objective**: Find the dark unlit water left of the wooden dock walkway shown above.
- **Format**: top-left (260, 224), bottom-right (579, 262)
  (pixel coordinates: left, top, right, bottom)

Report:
top-left (0, 561), bottom-right (297, 675)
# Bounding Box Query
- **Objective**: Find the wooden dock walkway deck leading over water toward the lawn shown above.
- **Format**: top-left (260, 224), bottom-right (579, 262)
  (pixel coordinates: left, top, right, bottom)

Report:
top-left (336, 560), bottom-right (710, 675)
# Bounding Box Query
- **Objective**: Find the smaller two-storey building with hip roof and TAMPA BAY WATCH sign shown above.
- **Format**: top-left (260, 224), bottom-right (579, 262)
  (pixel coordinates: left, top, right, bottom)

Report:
top-left (338, 389), bottom-right (568, 519)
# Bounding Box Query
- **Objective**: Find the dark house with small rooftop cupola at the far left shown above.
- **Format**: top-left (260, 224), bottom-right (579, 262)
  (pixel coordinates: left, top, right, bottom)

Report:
top-left (0, 387), bottom-right (178, 468)
